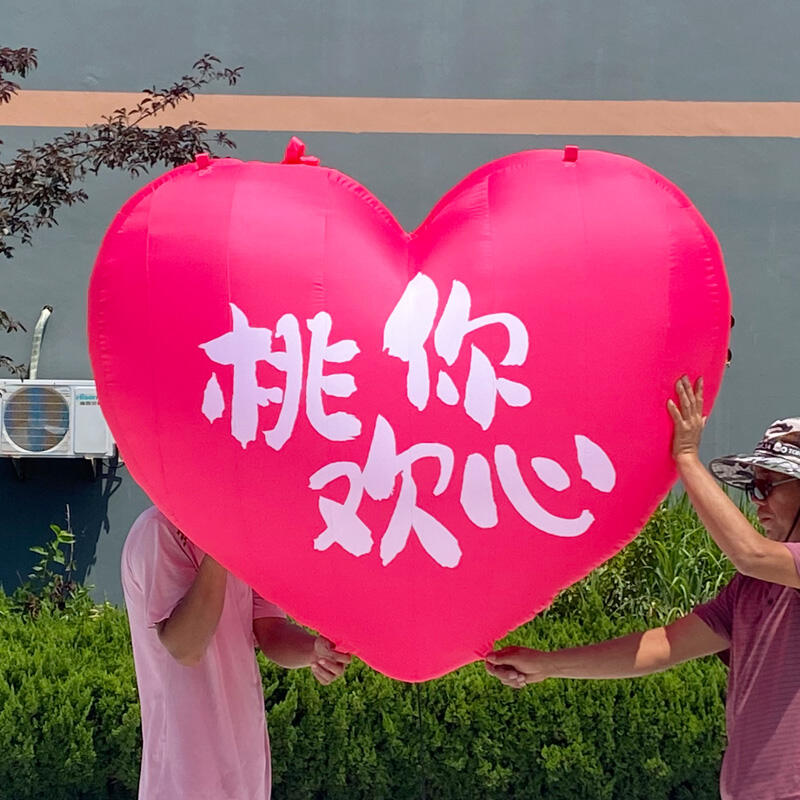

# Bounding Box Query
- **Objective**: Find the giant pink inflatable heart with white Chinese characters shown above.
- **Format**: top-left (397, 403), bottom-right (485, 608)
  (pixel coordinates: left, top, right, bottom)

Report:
top-left (89, 148), bottom-right (730, 681)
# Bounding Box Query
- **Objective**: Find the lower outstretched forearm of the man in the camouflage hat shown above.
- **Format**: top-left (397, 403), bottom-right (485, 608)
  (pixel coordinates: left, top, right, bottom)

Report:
top-left (542, 627), bottom-right (678, 679)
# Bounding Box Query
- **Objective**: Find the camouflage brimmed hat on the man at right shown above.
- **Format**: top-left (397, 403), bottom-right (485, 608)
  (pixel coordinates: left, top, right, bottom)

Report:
top-left (708, 417), bottom-right (800, 489)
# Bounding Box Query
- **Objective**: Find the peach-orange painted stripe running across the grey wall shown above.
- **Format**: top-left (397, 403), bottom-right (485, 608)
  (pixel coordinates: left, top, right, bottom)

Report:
top-left (0, 90), bottom-right (800, 138)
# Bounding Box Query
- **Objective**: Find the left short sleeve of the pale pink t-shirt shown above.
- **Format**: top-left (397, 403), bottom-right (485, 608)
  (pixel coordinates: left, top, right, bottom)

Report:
top-left (122, 514), bottom-right (199, 628)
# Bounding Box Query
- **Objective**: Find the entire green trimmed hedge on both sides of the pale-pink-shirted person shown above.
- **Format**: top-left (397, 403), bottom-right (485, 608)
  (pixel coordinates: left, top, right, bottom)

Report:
top-left (0, 595), bottom-right (725, 800)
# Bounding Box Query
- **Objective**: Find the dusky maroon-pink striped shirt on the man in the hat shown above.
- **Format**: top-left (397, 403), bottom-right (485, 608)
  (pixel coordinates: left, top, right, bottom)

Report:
top-left (694, 542), bottom-right (800, 800)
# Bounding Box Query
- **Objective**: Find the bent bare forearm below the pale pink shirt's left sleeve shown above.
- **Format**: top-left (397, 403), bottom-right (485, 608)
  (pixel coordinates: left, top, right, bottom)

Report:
top-left (158, 556), bottom-right (228, 666)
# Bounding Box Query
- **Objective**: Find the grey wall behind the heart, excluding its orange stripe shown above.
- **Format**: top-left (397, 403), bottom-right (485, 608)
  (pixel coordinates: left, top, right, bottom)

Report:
top-left (0, 0), bottom-right (800, 602)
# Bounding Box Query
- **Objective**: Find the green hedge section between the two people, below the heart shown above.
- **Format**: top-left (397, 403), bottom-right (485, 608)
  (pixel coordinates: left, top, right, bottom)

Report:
top-left (262, 600), bottom-right (725, 800)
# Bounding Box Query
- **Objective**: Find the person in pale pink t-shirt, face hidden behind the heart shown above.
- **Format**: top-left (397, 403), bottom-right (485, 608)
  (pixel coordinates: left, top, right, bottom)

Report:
top-left (122, 508), bottom-right (350, 800)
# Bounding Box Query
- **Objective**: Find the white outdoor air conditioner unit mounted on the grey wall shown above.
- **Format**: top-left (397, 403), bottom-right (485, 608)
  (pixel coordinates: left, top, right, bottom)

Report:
top-left (0, 379), bottom-right (116, 459)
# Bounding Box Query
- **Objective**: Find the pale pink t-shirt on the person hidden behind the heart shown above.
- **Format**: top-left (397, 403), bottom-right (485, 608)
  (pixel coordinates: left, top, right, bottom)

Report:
top-left (122, 508), bottom-right (284, 800)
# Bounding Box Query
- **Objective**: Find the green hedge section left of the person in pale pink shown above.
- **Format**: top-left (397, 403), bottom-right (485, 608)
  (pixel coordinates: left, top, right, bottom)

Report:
top-left (0, 595), bottom-right (141, 800)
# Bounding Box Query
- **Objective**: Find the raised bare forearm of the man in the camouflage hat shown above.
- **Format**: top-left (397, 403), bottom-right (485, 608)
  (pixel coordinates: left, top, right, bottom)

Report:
top-left (675, 454), bottom-right (765, 574)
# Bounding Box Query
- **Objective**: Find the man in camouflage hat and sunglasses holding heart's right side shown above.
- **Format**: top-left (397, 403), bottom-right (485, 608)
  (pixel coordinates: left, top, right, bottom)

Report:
top-left (486, 376), bottom-right (800, 800)
